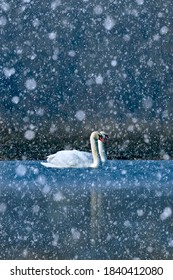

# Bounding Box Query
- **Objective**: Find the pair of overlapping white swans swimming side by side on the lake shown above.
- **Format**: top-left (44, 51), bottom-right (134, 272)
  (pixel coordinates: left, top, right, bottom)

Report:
top-left (41, 131), bottom-right (108, 168)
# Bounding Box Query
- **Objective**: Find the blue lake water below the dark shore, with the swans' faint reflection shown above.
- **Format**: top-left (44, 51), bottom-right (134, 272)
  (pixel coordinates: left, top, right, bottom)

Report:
top-left (0, 161), bottom-right (173, 259)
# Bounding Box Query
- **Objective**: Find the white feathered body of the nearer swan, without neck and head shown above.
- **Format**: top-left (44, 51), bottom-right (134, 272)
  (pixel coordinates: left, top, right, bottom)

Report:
top-left (44, 150), bottom-right (92, 168)
